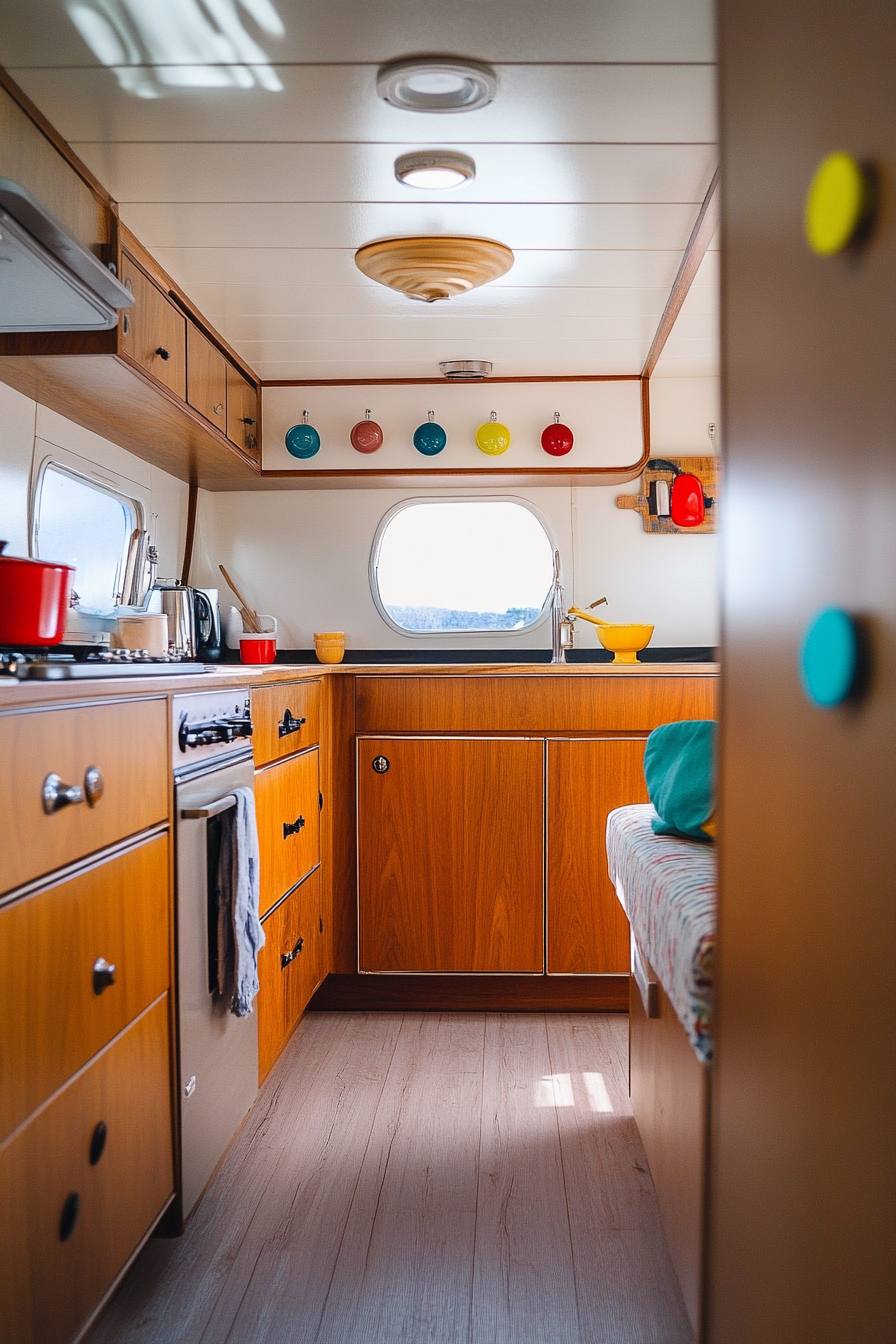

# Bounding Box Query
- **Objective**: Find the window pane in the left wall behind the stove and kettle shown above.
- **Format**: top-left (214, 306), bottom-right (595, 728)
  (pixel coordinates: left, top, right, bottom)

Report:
top-left (34, 462), bottom-right (138, 616)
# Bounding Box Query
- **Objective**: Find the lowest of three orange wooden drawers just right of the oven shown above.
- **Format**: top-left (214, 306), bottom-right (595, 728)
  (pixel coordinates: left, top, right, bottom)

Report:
top-left (258, 872), bottom-right (322, 1082)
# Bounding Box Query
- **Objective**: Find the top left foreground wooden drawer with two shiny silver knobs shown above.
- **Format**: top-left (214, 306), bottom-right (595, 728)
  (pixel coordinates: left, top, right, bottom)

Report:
top-left (0, 700), bottom-right (168, 891)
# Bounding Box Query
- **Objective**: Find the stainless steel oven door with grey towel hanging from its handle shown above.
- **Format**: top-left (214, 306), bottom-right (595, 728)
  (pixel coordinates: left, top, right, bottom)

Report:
top-left (175, 749), bottom-right (258, 1218)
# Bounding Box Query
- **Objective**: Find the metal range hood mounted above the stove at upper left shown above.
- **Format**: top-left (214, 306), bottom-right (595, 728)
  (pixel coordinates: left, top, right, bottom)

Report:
top-left (0, 177), bottom-right (134, 332)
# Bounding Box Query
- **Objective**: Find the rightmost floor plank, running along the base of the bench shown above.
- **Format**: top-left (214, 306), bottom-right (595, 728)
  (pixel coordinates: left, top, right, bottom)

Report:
top-left (545, 1015), bottom-right (693, 1344)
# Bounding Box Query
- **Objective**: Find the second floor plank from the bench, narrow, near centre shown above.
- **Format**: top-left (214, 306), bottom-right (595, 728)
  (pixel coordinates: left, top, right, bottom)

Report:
top-left (472, 1013), bottom-right (582, 1344)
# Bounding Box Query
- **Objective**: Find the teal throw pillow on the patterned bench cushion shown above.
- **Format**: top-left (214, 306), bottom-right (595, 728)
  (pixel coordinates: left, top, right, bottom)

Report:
top-left (643, 719), bottom-right (719, 841)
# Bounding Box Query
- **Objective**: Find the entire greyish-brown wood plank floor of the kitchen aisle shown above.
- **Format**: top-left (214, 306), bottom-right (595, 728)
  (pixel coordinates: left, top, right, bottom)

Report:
top-left (90, 1012), bottom-right (690, 1344)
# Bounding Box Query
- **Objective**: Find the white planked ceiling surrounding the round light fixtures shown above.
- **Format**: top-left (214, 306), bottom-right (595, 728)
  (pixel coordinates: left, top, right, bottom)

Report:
top-left (0, 0), bottom-right (717, 379)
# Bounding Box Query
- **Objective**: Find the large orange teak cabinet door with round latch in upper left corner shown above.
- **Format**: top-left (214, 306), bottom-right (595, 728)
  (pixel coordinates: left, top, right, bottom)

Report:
top-left (357, 738), bottom-right (544, 973)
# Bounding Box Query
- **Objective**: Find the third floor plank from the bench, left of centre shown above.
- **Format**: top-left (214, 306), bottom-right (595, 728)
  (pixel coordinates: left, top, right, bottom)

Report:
top-left (311, 1013), bottom-right (485, 1344)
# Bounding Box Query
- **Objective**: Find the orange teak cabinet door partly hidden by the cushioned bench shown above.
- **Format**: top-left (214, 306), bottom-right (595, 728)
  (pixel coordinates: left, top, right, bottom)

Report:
top-left (547, 738), bottom-right (649, 976)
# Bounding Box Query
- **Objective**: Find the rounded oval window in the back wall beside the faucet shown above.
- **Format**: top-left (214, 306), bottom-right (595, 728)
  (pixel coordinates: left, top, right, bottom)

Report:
top-left (371, 499), bottom-right (553, 634)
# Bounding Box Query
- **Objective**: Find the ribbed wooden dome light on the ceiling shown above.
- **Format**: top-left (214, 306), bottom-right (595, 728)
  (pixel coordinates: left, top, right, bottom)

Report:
top-left (355, 234), bottom-right (513, 304)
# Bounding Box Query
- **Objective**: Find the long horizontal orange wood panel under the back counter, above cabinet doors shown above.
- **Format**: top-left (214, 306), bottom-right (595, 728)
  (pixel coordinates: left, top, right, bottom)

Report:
top-left (355, 673), bottom-right (717, 732)
